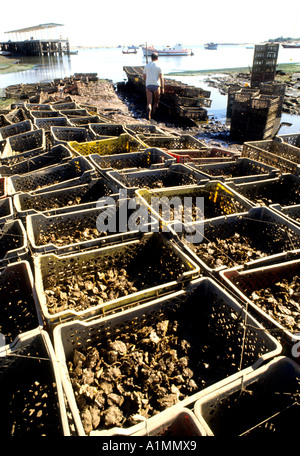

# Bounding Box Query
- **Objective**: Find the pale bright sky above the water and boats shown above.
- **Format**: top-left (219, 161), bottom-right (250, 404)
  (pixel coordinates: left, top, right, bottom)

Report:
top-left (0, 0), bottom-right (300, 46)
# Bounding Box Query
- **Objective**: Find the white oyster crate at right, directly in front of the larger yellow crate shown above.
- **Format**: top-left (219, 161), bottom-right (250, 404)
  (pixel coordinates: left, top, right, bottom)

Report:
top-left (170, 207), bottom-right (300, 276)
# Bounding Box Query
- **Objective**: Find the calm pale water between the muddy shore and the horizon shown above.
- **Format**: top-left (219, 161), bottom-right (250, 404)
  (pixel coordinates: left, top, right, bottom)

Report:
top-left (0, 45), bottom-right (300, 134)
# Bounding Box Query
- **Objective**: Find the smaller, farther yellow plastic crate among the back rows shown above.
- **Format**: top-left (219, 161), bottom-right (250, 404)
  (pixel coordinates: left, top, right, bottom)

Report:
top-left (68, 133), bottom-right (147, 155)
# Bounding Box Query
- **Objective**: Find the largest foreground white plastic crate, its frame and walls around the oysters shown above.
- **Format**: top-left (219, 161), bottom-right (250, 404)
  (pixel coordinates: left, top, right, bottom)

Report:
top-left (53, 278), bottom-right (282, 435)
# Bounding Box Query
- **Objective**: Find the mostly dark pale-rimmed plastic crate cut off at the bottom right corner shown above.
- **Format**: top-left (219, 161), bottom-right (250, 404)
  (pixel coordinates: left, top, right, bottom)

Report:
top-left (194, 356), bottom-right (300, 434)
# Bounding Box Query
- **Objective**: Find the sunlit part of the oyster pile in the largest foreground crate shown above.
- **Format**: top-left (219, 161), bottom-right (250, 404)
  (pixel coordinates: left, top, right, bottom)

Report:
top-left (68, 320), bottom-right (197, 434)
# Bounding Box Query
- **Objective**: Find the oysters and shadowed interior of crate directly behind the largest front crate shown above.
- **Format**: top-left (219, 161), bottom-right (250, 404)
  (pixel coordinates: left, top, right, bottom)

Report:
top-left (44, 236), bottom-right (187, 314)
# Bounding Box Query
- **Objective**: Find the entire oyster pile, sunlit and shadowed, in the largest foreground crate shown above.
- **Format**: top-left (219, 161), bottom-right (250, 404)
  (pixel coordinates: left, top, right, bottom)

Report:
top-left (67, 297), bottom-right (252, 434)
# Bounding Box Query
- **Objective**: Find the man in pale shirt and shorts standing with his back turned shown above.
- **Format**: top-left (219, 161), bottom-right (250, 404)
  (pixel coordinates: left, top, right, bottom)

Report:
top-left (143, 52), bottom-right (164, 120)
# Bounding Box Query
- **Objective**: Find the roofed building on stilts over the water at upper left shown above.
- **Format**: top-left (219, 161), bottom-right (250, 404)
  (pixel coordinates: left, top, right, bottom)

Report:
top-left (0, 23), bottom-right (70, 56)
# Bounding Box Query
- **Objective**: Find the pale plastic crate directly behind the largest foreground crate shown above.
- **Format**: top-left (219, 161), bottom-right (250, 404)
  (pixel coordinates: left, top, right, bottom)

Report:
top-left (33, 232), bottom-right (199, 326)
